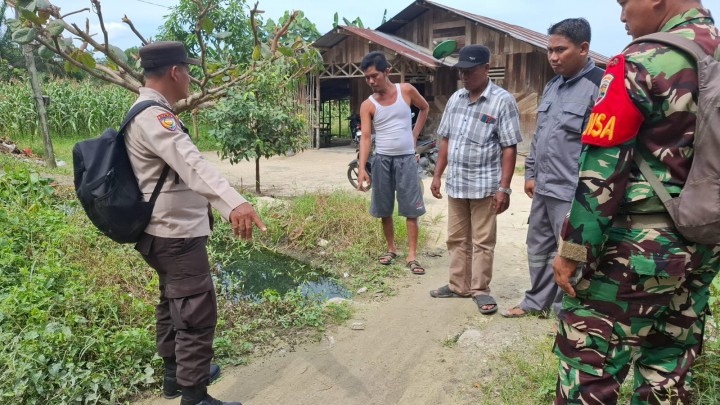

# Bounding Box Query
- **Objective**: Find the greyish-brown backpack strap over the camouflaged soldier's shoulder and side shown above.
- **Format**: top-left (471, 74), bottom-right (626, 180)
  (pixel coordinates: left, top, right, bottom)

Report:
top-left (628, 32), bottom-right (707, 204)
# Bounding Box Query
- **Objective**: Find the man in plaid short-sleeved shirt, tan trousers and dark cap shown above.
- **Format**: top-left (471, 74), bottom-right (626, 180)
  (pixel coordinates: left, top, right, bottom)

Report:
top-left (430, 45), bottom-right (522, 315)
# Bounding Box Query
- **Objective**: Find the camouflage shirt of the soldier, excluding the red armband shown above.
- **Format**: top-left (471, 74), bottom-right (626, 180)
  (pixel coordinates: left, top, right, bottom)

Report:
top-left (558, 8), bottom-right (720, 262)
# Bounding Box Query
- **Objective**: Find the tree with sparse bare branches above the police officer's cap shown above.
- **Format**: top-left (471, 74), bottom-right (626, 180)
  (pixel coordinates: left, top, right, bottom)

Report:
top-left (7, 0), bottom-right (322, 113)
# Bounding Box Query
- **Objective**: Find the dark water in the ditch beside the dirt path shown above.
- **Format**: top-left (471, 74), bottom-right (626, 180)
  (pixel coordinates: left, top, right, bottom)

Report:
top-left (215, 241), bottom-right (352, 301)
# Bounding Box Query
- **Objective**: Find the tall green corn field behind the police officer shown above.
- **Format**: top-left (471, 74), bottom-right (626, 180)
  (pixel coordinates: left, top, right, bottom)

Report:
top-left (0, 80), bottom-right (137, 138)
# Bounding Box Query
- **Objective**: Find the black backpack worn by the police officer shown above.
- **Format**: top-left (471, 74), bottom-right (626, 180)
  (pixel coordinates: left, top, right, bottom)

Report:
top-left (73, 100), bottom-right (170, 243)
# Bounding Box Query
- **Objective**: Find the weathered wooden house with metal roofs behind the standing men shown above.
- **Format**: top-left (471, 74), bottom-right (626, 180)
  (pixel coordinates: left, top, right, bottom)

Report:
top-left (308, 0), bottom-right (607, 151)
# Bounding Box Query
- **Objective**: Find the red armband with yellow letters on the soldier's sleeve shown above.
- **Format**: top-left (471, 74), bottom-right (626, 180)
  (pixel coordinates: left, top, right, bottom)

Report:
top-left (582, 55), bottom-right (645, 148)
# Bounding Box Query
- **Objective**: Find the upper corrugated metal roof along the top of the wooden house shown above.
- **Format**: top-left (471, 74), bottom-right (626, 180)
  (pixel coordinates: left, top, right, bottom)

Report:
top-left (377, 0), bottom-right (609, 65)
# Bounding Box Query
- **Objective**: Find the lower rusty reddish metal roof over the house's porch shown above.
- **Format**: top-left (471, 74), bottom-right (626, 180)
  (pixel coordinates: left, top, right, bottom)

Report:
top-left (313, 25), bottom-right (452, 69)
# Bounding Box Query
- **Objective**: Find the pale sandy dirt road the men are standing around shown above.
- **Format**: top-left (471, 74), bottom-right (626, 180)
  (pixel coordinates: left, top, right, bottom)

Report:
top-left (142, 146), bottom-right (551, 405)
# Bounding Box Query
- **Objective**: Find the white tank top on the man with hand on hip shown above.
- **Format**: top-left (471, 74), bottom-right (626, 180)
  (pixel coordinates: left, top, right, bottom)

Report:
top-left (368, 83), bottom-right (415, 156)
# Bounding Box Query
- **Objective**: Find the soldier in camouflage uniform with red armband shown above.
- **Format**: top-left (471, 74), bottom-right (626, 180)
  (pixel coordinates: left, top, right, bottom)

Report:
top-left (553, 0), bottom-right (720, 404)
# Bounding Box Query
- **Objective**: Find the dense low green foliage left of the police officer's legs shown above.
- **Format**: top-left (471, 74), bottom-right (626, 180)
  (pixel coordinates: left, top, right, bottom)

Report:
top-left (0, 165), bottom-right (155, 404)
